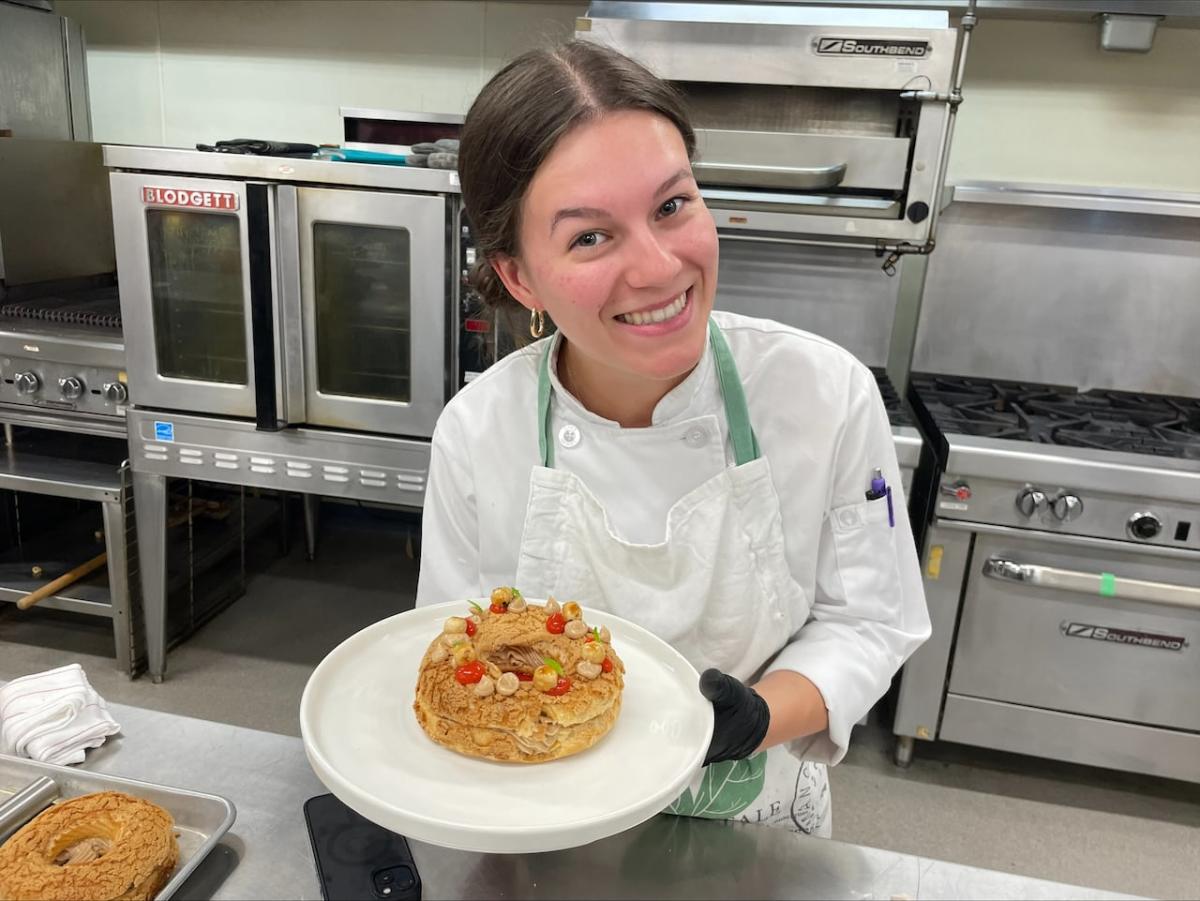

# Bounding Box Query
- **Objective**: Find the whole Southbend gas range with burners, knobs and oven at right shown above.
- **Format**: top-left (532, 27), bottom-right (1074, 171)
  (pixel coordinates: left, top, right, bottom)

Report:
top-left (893, 373), bottom-right (1200, 782)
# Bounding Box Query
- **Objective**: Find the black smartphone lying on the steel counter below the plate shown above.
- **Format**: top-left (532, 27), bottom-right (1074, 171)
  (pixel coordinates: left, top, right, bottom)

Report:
top-left (304, 794), bottom-right (421, 901)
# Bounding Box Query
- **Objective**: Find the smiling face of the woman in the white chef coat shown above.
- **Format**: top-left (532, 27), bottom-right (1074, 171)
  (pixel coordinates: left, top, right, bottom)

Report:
top-left (497, 110), bottom-right (718, 390)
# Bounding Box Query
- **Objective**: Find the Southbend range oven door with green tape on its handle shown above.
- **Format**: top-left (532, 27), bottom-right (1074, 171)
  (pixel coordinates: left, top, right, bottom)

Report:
top-left (950, 534), bottom-right (1200, 732)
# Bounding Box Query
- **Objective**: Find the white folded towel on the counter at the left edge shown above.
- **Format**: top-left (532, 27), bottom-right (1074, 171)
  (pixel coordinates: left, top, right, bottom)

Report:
top-left (0, 663), bottom-right (121, 764)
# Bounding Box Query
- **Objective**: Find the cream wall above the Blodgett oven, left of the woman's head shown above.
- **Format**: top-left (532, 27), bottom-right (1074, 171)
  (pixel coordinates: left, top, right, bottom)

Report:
top-left (56, 0), bottom-right (587, 146)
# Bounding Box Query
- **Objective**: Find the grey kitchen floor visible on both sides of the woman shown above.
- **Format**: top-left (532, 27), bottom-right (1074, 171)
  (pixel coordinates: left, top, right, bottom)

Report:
top-left (0, 505), bottom-right (1200, 897)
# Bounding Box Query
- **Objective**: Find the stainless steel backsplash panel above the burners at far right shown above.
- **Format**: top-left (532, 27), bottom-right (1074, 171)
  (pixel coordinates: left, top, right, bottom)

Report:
top-left (912, 203), bottom-right (1200, 397)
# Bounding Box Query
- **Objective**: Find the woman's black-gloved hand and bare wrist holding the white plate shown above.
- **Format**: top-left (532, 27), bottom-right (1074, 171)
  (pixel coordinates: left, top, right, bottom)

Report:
top-left (700, 669), bottom-right (829, 767)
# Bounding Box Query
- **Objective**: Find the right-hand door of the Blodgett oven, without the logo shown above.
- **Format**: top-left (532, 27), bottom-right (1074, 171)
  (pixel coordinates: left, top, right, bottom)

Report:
top-left (296, 187), bottom-right (450, 438)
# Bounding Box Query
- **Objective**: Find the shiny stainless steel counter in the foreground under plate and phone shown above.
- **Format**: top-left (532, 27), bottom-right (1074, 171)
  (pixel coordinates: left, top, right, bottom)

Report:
top-left (0, 704), bottom-right (1130, 899)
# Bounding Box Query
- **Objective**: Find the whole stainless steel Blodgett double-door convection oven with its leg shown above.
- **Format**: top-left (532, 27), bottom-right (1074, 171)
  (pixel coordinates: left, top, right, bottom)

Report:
top-left (104, 146), bottom-right (481, 680)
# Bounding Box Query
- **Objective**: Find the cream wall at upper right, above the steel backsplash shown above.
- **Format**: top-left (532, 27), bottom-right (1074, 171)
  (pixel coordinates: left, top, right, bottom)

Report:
top-left (950, 16), bottom-right (1200, 192)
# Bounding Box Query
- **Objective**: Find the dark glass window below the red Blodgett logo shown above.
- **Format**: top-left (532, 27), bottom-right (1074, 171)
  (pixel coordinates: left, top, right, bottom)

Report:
top-left (146, 210), bottom-right (247, 385)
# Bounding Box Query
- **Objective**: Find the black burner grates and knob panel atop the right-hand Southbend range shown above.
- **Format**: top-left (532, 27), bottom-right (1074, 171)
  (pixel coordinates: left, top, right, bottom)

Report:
top-left (910, 373), bottom-right (1200, 549)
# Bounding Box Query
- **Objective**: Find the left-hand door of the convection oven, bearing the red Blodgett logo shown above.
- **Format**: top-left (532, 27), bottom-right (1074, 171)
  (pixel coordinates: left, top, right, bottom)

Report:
top-left (109, 172), bottom-right (280, 427)
